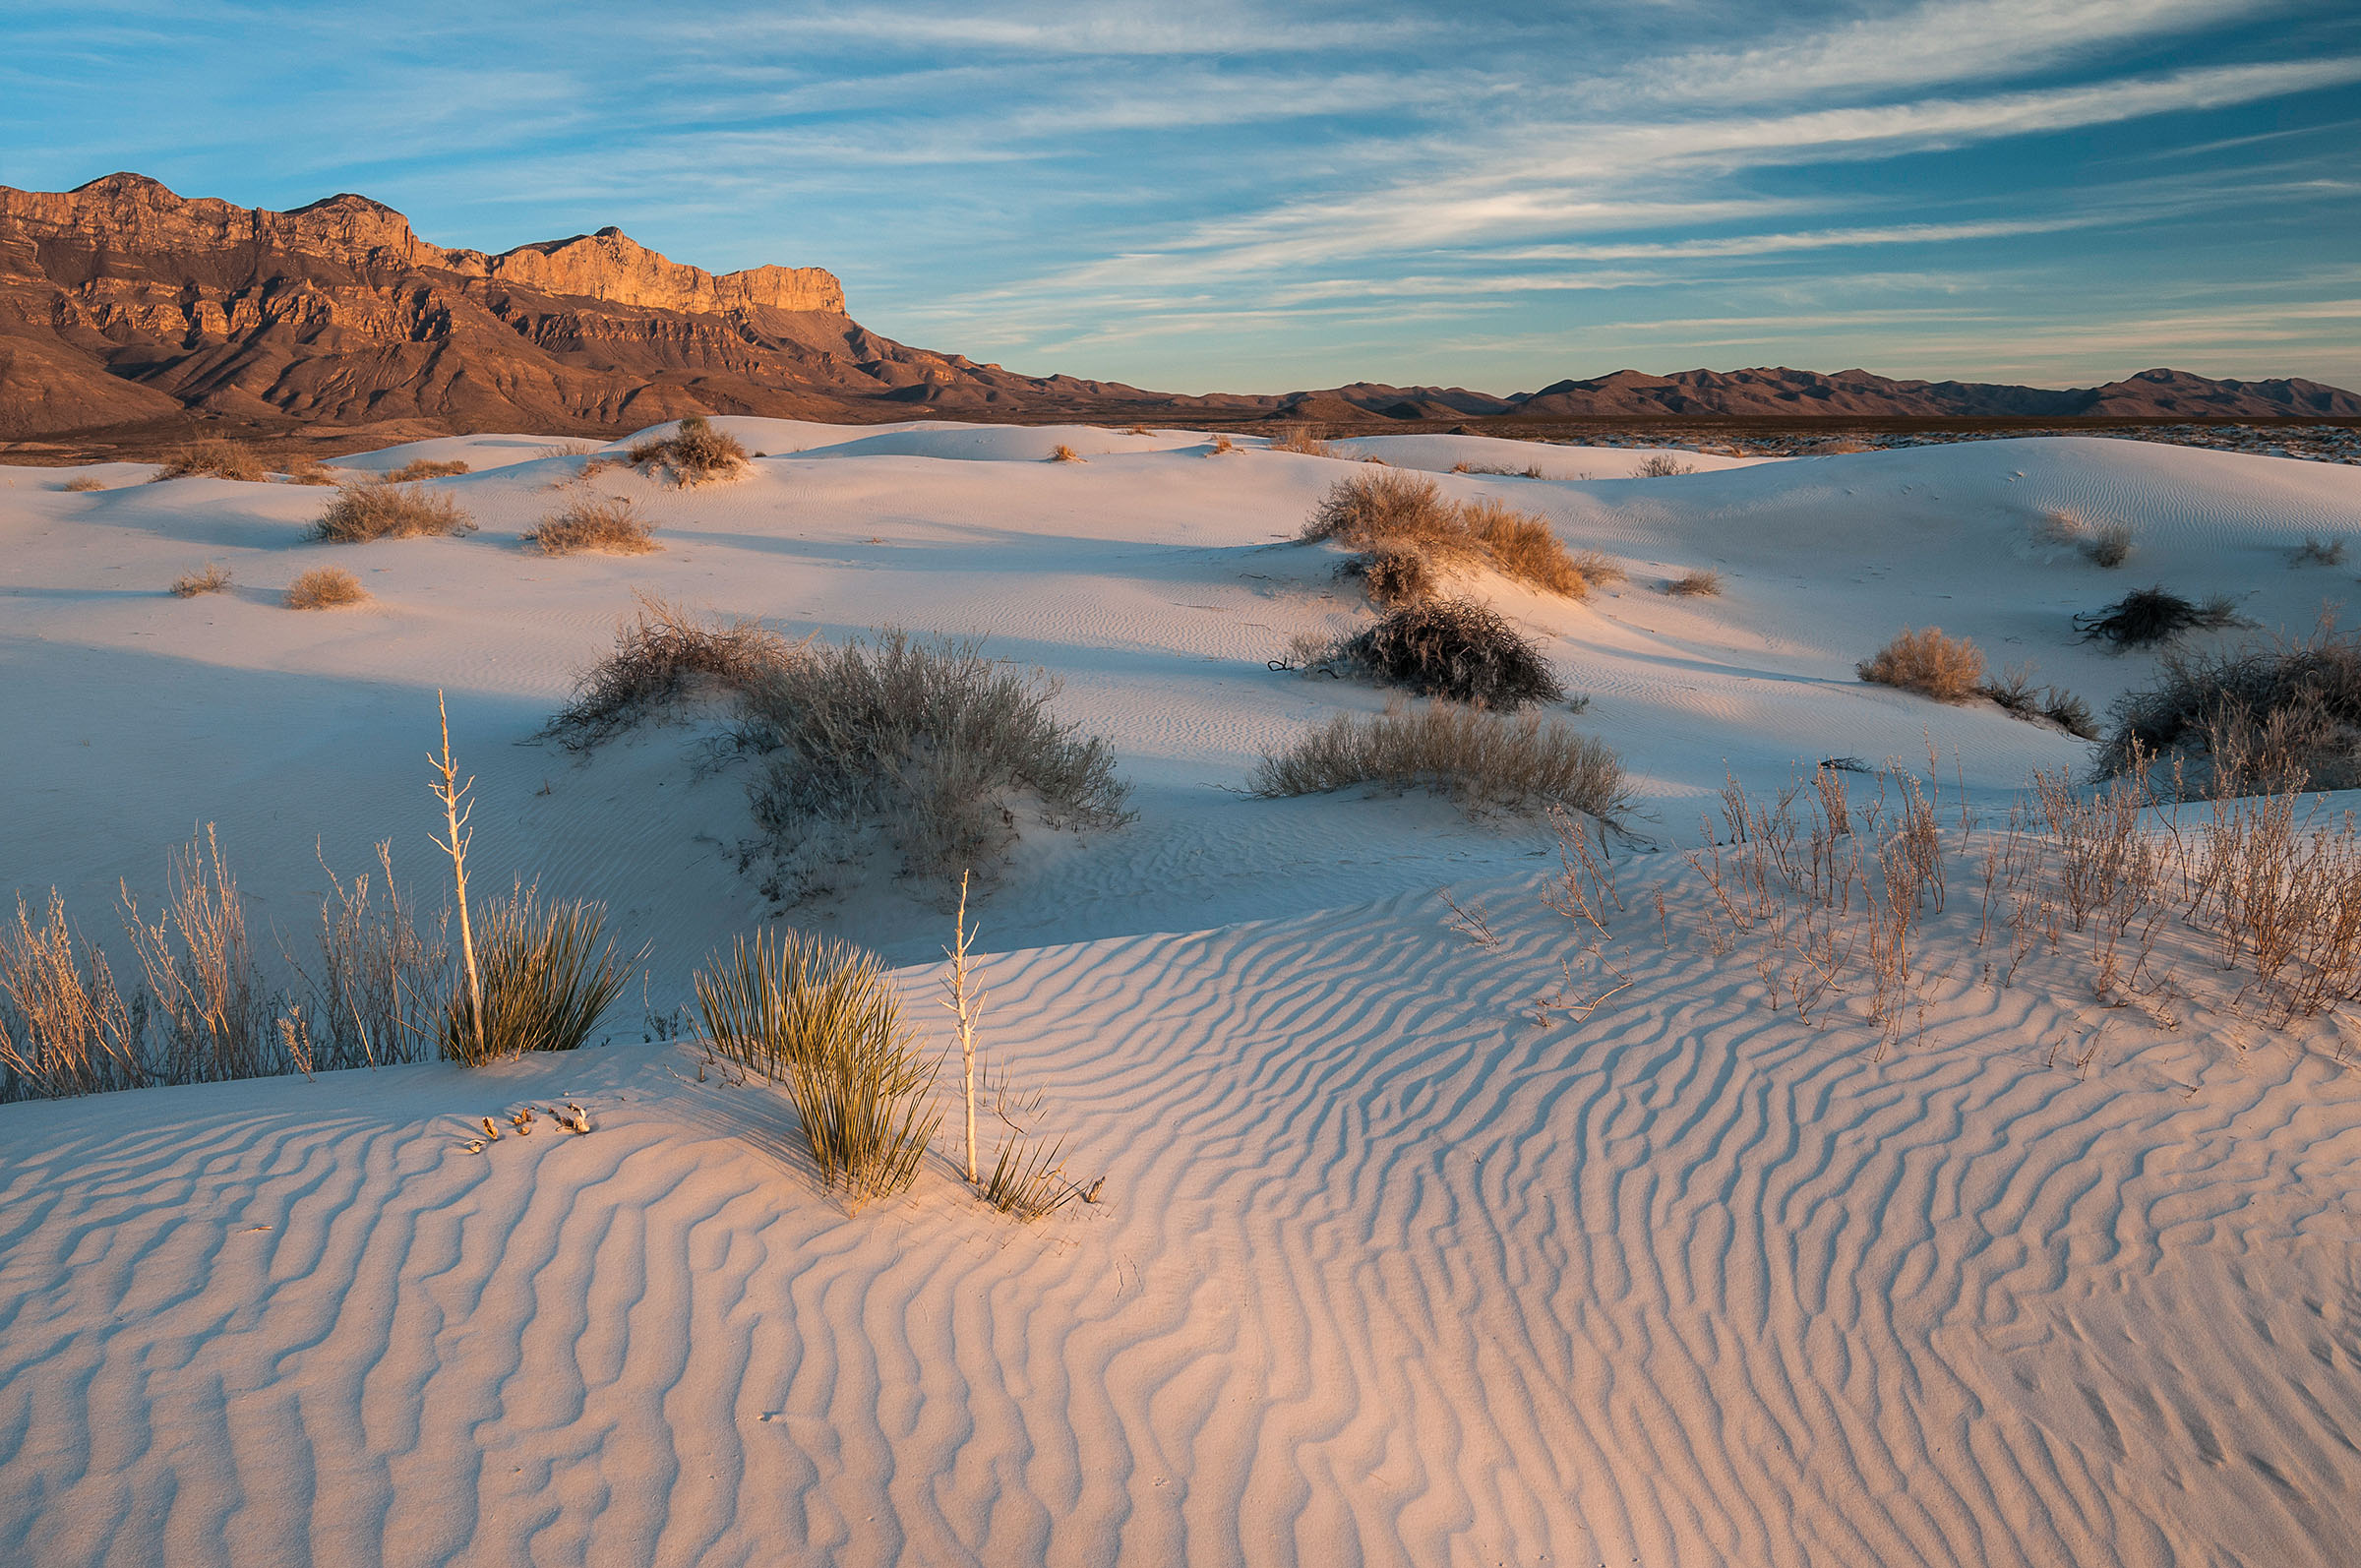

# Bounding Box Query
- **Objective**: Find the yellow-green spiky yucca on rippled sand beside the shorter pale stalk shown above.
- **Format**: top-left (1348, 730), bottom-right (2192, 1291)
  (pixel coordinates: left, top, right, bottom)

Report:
top-left (695, 931), bottom-right (942, 1207)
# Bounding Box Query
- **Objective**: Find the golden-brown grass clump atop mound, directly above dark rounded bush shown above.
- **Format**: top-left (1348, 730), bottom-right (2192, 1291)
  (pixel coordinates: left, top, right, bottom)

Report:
top-left (1303, 470), bottom-right (1622, 605)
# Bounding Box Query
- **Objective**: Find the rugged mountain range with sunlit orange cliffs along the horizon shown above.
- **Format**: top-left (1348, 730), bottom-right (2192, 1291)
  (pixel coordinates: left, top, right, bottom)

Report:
top-left (0, 175), bottom-right (2361, 440)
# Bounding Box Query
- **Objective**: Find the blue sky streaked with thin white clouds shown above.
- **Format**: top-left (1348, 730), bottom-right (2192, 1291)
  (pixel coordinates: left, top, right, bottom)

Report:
top-left (0, 0), bottom-right (2361, 392)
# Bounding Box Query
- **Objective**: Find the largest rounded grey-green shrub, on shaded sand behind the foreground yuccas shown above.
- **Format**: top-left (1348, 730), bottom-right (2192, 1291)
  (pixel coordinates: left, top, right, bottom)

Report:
top-left (737, 631), bottom-right (1128, 897)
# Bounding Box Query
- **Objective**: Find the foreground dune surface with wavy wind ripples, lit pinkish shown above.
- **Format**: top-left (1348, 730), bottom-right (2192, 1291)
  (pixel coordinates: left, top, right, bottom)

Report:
top-left (0, 874), bottom-right (2361, 1568)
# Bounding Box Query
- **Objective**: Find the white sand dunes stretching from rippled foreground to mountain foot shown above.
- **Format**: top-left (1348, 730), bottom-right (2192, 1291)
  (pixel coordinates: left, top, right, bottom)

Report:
top-left (0, 420), bottom-right (2361, 1568)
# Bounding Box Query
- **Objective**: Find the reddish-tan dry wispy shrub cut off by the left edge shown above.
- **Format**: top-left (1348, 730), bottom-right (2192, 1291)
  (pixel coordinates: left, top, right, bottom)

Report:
top-left (0, 888), bottom-right (149, 1103)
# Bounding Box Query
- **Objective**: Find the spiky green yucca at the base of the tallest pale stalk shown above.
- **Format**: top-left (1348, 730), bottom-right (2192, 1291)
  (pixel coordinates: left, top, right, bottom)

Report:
top-left (442, 885), bottom-right (631, 1067)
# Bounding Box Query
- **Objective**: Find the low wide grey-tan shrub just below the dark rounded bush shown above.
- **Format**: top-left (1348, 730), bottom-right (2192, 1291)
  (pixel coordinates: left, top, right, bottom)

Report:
top-left (1249, 701), bottom-right (1629, 821)
